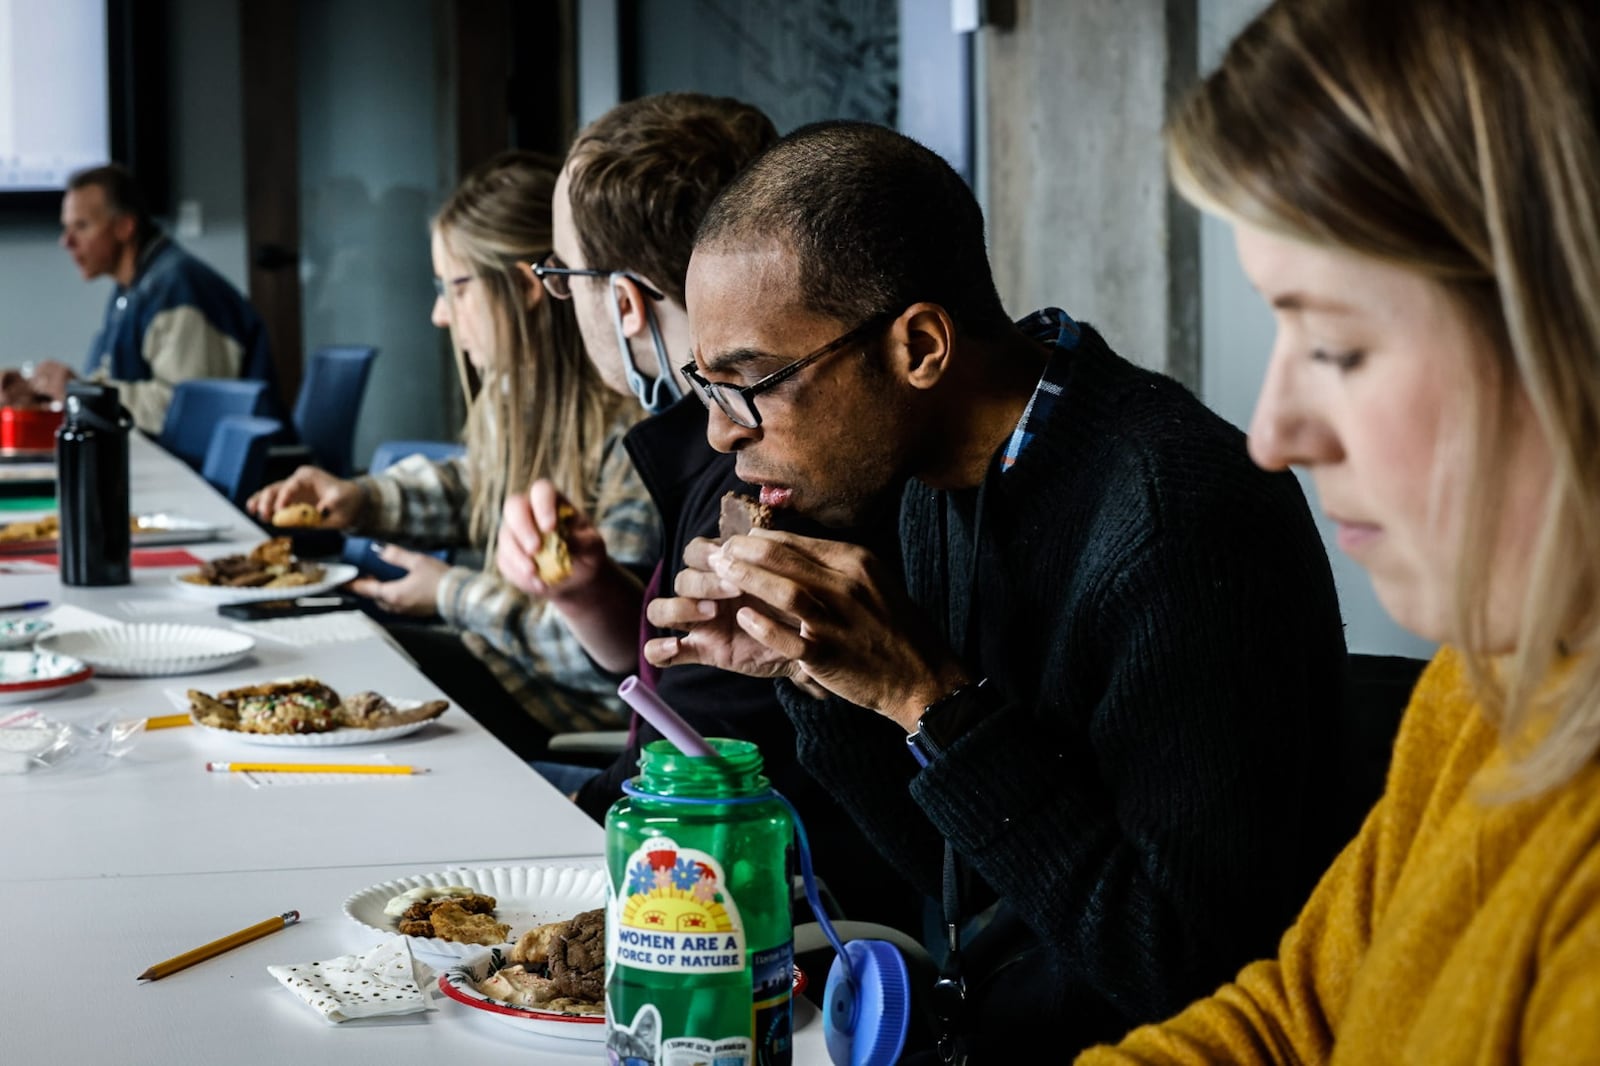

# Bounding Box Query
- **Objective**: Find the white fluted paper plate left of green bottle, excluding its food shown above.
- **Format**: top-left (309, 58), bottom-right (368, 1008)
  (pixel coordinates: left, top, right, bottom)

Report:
top-left (344, 860), bottom-right (606, 959)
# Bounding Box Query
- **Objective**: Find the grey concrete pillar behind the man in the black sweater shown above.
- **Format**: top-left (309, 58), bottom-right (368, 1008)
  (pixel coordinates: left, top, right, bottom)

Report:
top-left (979, 0), bottom-right (1200, 382)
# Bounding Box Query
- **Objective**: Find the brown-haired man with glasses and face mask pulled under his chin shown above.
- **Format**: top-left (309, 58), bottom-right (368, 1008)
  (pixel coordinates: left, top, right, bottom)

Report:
top-left (496, 93), bottom-right (920, 927)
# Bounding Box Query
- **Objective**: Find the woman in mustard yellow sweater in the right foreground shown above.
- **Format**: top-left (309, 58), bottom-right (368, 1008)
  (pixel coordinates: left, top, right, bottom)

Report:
top-left (1078, 0), bottom-right (1600, 1066)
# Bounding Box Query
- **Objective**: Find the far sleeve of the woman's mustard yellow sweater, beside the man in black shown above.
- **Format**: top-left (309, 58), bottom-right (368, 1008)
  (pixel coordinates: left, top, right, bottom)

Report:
top-left (1077, 650), bottom-right (1467, 1066)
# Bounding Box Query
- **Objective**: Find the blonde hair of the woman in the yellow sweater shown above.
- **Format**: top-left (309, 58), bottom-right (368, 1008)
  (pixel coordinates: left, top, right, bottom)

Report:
top-left (1166, 0), bottom-right (1600, 797)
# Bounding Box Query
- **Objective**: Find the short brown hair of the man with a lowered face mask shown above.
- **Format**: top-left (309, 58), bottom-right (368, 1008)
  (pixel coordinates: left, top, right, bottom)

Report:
top-left (566, 93), bottom-right (778, 306)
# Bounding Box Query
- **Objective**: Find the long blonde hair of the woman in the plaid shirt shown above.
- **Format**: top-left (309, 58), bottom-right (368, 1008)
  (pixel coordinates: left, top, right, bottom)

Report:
top-left (432, 152), bottom-right (632, 570)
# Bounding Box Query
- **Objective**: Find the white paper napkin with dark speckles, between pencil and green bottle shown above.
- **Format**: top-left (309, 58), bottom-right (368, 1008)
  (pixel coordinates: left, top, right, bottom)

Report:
top-left (267, 936), bottom-right (438, 1023)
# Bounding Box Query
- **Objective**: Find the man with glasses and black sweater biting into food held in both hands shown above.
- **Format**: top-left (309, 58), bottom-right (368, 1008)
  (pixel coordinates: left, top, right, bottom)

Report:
top-left (645, 123), bottom-right (1355, 1061)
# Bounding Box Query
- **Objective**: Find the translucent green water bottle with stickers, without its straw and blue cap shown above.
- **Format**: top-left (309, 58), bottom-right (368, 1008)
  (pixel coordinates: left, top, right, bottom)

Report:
top-left (605, 739), bottom-right (794, 1066)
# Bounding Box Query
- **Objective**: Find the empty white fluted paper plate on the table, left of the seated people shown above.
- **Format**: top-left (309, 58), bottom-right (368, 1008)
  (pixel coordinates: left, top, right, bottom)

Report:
top-left (37, 623), bottom-right (256, 677)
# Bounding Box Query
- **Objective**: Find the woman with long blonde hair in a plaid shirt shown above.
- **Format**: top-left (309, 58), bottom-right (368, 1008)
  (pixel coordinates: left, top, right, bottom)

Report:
top-left (248, 152), bottom-right (661, 759)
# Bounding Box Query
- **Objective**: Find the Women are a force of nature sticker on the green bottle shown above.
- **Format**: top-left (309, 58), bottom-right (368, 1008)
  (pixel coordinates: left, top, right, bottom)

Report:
top-left (606, 837), bottom-right (746, 973)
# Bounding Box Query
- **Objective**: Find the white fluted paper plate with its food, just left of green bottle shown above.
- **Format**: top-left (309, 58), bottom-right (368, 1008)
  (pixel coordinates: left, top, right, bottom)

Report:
top-left (344, 860), bottom-right (606, 959)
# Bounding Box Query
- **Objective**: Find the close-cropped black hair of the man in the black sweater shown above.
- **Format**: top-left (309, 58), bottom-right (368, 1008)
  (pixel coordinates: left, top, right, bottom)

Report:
top-left (696, 122), bottom-right (1011, 336)
